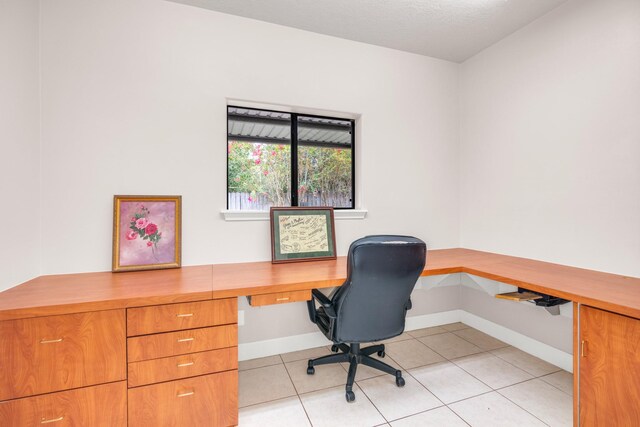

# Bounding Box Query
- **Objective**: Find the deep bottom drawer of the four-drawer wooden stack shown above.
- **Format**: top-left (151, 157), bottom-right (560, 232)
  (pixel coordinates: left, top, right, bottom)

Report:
top-left (128, 371), bottom-right (238, 427)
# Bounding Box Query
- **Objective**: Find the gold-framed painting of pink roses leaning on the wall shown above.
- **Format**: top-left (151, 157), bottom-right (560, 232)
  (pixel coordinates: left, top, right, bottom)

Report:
top-left (112, 196), bottom-right (182, 272)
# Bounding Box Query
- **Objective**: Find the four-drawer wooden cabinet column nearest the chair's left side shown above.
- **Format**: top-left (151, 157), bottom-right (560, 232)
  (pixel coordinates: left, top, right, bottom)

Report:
top-left (127, 298), bottom-right (238, 426)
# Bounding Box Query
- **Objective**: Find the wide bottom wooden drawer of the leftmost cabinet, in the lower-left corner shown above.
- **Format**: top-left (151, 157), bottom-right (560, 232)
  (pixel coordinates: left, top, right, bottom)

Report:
top-left (0, 381), bottom-right (127, 427)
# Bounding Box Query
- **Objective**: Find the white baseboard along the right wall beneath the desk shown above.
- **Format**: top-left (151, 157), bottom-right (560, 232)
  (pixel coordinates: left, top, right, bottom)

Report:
top-left (460, 310), bottom-right (573, 372)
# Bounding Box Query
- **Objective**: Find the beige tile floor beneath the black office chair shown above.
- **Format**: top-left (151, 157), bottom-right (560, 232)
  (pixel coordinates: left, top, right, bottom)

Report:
top-left (240, 323), bottom-right (573, 427)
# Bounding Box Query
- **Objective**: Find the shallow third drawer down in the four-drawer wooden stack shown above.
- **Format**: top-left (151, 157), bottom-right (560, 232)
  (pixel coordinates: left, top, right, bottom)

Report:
top-left (129, 347), bottom-right (238, 387)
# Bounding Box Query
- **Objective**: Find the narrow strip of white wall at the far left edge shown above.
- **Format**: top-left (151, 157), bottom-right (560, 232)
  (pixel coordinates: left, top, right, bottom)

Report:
top-left (0, 0), bottom-right (41, 291)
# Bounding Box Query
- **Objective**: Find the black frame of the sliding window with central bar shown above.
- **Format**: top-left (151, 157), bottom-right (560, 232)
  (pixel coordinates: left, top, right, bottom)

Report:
top-left (226, 104), bottom-right (356, 212)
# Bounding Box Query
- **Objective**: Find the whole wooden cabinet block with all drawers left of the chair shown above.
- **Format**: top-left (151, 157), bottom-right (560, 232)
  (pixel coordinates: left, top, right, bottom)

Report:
top-left (0, 298), bottom-right (238, 427)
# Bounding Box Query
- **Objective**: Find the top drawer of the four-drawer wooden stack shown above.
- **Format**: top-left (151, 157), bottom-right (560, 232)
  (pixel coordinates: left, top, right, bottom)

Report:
top-left (127, 298), bottom-right (238, 337)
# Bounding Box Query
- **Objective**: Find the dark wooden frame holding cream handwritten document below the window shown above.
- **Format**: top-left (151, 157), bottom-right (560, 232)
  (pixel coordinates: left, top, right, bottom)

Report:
top-left (269, 207), bottom-right (336, 264)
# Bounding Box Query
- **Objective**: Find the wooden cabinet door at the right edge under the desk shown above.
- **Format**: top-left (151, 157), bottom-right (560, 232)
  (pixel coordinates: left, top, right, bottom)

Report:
top-left (576, 305), bottom-right (640, 426)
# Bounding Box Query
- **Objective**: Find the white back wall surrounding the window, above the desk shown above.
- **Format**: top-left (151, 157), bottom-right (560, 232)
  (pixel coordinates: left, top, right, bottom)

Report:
top-left (41, 0), bottom-right (459, 273)
